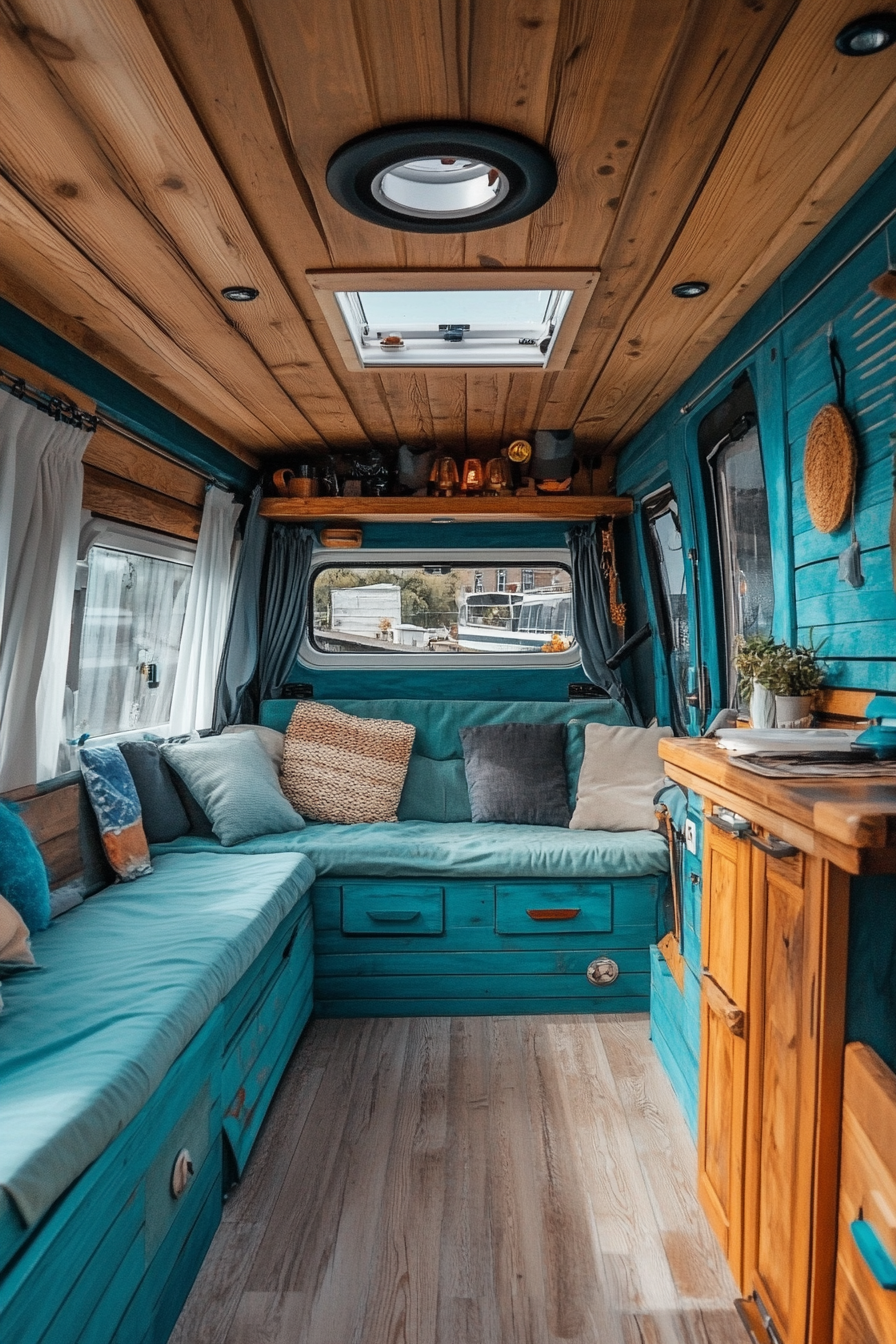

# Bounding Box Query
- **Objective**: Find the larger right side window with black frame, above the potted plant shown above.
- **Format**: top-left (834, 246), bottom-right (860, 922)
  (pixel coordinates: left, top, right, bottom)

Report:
top-left (699, 379), bottom-right (775, 704)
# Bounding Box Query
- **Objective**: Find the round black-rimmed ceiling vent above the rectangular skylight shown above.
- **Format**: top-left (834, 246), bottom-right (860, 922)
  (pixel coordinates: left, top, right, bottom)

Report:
top-left (326, 121), bottom-right (557, 234)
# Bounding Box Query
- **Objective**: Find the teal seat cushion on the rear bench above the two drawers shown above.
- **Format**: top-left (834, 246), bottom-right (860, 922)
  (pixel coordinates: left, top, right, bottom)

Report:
top-left (152, 821), bottom-right (669, 882)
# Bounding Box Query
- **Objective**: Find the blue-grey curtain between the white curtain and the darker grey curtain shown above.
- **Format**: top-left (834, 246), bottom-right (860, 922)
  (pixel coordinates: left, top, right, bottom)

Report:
top-left (214, 485), bottom-right (267, 732)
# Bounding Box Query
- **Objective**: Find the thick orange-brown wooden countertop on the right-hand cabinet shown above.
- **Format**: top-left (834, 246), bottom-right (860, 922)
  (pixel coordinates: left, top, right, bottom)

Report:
top-left (660, 738), bottom-right (896, 872)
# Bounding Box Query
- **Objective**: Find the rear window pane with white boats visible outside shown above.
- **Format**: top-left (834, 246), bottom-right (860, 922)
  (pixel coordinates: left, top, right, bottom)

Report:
top-left (309, 562), bottom-right (575, 657)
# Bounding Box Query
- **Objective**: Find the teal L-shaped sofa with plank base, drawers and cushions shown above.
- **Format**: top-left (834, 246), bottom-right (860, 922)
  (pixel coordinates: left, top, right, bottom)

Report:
top-left (0, 699), bottom-right (669, 1344)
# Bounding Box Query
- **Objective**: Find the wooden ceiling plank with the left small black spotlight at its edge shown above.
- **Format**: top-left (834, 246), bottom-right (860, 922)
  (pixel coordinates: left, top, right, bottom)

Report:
top-left (6, 0), bottom-right (361, 442)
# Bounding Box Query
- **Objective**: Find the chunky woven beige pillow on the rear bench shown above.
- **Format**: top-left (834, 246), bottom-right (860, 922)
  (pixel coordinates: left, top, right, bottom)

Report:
top-left (279, 700), bottom-right (416, 825)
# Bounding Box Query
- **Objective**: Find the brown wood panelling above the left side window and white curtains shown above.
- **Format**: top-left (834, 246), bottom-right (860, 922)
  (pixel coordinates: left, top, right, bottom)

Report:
top-left (0, 347), bottom-right (206, 542)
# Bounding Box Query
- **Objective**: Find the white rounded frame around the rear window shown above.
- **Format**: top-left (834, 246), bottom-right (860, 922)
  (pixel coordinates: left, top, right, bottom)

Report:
top-left (298, 543), bottom-right (582, 675)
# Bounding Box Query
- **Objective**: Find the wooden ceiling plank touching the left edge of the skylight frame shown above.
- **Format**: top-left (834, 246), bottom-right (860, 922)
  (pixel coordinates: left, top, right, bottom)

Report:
top-left (141, 0), bottom-right (395, 444)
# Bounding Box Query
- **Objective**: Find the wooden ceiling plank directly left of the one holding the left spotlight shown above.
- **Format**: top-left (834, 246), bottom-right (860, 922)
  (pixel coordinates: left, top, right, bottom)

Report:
top-left (0, 5), bottom-right (320, 446)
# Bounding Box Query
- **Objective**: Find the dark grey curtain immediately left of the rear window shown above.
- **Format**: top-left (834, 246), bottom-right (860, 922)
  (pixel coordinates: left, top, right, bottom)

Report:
top-left (258, 523), bottom-right (314, 700)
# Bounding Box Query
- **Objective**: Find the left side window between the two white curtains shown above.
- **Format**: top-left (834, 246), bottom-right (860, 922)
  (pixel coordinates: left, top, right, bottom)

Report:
top-left (66, 523), bottom-right (192, 738)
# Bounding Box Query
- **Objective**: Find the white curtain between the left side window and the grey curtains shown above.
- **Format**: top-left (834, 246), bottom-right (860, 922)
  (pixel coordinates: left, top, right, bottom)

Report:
top-left (169, 485), bottom-right (240, 734)
